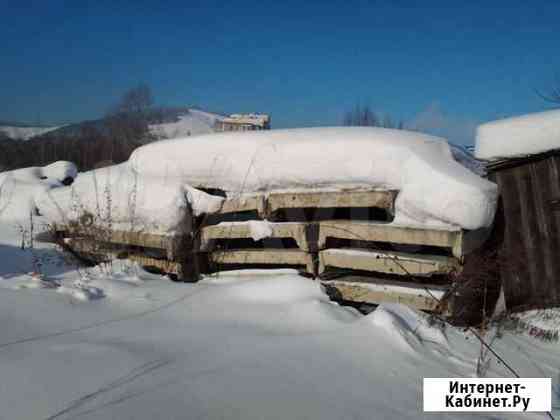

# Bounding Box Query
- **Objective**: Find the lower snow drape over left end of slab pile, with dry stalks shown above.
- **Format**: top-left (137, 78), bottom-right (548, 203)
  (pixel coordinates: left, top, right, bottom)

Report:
top-left (36, 163), bottom-right (223, 233)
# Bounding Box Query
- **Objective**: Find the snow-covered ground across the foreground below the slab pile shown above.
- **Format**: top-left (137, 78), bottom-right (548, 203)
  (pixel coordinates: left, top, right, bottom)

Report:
top-left (0, 160), bottom-right (560, 420)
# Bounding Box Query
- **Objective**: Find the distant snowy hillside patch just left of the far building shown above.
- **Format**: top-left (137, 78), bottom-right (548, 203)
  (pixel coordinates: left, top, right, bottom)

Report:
top-left (150, 108), bottom-right (222, 139)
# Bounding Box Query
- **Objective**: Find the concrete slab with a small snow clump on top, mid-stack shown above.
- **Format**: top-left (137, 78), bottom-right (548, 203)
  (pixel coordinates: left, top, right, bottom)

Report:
top-left (200, 221), bottom-right (310, 251)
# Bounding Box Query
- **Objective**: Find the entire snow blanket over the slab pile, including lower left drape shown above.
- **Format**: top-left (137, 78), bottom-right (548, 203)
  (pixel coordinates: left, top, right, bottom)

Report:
top-left (37, 127), bottom-right (497, 232)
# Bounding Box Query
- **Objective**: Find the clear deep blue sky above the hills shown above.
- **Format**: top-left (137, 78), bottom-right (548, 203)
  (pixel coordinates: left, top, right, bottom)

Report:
top-left (0, 0), bottom-right (560, 143)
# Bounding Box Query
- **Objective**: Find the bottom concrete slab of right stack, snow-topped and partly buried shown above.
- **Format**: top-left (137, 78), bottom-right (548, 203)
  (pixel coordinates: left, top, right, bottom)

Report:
top-left (322, 278), bottom-right (450, 315)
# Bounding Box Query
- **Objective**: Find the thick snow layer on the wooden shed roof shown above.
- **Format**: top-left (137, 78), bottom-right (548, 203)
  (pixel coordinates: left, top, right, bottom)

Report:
top-left (475, 110), bottom-right (560, 160)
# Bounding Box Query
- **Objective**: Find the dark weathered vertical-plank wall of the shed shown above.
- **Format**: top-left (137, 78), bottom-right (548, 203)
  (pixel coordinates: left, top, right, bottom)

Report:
top-left (488, 152), bottom-right (560, 310)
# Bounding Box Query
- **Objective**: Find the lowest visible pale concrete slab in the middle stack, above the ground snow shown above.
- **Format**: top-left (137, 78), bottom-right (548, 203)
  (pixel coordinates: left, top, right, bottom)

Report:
top-left (210, 249), bottom-right (315, 274)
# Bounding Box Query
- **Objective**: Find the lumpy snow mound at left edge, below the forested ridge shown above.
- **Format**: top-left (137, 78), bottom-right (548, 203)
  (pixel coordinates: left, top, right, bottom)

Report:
top-left (0, 161), bottom-right (78, 220)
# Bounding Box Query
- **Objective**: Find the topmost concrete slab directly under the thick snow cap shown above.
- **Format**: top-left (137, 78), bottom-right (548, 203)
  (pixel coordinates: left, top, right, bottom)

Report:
top-left (267, 190), bottom-right (397, 213)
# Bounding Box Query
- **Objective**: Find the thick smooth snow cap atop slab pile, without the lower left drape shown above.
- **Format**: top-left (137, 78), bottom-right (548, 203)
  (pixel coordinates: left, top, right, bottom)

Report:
top-left (129, 127), bottom-right (497, 229)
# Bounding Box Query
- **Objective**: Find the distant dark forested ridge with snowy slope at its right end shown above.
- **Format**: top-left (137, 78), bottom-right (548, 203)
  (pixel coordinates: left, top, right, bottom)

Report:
top-left (0, 107), bottom-right (228, 172)
